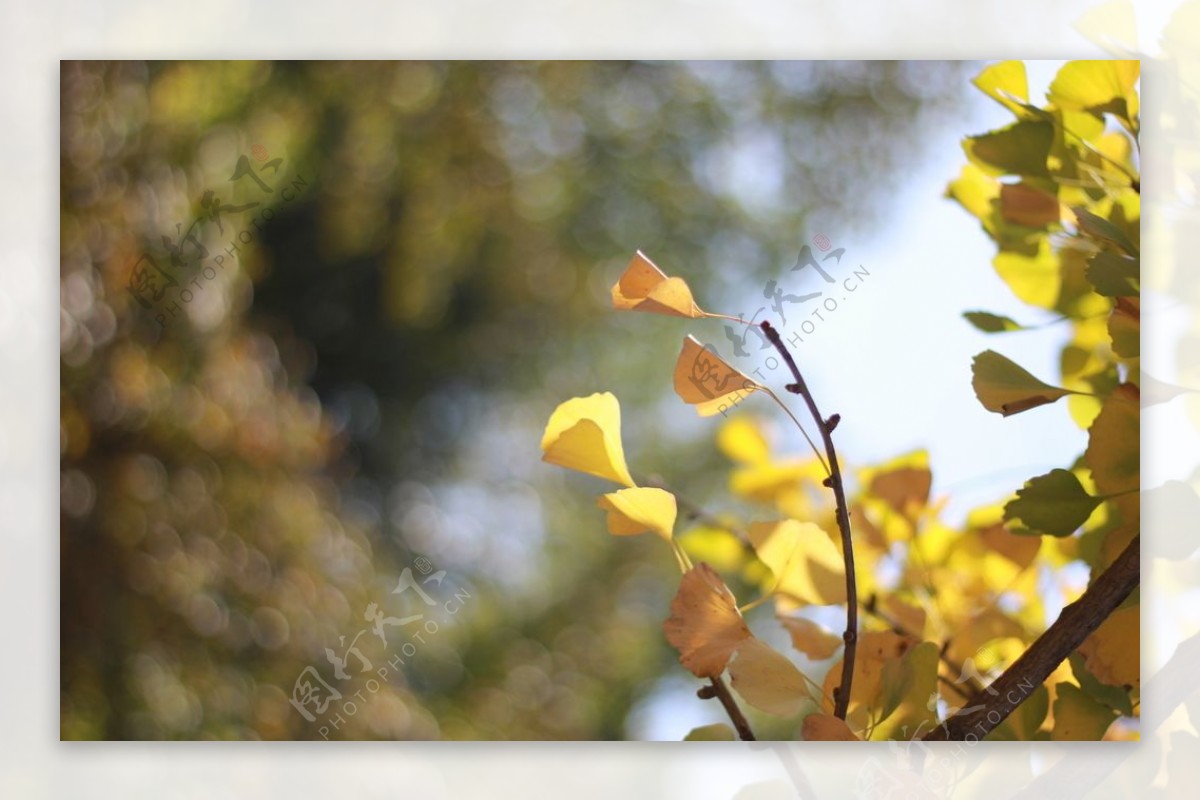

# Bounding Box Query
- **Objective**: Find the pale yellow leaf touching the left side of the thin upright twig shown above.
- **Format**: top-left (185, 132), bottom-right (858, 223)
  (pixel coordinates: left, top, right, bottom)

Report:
top-left (749, 520), bottom-right (846, 606)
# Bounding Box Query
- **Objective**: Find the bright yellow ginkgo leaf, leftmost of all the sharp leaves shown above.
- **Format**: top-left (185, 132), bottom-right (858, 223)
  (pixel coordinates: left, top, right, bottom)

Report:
top-left (541, 392), bottom-right (635, 487)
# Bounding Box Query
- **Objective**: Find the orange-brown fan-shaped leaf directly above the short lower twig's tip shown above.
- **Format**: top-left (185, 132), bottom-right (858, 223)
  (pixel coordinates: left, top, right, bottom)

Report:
top-left (662, 562), bottom-right (752, 677)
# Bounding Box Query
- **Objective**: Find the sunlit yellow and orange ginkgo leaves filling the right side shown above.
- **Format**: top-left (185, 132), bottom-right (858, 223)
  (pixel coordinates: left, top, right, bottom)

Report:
top-left (542, 61), bottom-right (1140, 740)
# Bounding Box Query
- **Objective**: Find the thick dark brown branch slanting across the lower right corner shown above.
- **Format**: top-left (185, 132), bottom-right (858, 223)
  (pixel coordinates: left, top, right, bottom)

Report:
top-left (924, 536), bottom-right (1141, 740)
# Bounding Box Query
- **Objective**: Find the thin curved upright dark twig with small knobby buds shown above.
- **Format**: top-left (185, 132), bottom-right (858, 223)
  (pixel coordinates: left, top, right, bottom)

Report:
top-left (761, 320), bottom-right (858, 721)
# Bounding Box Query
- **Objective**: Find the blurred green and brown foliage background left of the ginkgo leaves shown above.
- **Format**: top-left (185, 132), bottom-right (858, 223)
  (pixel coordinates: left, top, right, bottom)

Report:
top-left (60, 62), bottom-right (976, 740)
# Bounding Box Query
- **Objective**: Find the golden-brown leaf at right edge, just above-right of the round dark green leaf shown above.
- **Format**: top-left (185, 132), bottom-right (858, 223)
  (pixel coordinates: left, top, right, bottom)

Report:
top-left (1084, 384), bottom-right (1141, 495)
